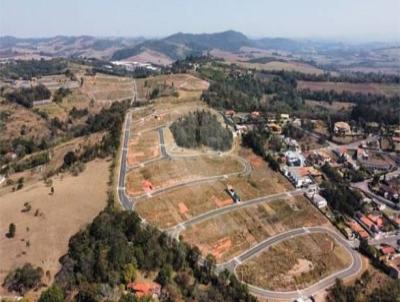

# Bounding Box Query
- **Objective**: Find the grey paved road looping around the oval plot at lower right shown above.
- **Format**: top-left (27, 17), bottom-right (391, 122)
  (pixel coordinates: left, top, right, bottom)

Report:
top-left (218, 227), bottom-right (362, 300)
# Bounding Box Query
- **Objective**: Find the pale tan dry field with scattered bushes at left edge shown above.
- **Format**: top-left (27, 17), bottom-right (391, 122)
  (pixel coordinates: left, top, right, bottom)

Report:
top-left (0, 160), bottom-right (110, 293)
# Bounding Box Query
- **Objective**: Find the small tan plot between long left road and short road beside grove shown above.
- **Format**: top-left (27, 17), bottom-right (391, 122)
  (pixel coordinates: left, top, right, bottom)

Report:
top-left (127, 130), bottom-right (160, 166)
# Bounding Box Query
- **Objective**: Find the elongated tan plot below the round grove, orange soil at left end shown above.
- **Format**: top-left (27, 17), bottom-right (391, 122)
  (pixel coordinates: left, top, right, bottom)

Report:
top-left (126, 156), bottom-right (243, 195)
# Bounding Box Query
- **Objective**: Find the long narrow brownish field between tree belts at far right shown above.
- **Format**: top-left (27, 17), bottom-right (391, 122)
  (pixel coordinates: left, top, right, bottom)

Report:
top-left (297, 81), bottom-right (400, 96)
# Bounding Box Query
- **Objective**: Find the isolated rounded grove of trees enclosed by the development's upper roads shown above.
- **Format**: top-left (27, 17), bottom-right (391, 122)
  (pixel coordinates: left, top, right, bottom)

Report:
top-left (170, 110), bottom-right (233, 151)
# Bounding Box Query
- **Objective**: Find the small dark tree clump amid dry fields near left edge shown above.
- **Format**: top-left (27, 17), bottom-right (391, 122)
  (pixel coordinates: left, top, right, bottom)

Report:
top-left (5, 84), bottom-right (51, 108)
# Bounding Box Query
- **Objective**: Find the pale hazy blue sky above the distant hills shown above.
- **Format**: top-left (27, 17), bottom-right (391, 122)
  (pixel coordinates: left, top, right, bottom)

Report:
top-left (0, 0), bottom-right (400, 40)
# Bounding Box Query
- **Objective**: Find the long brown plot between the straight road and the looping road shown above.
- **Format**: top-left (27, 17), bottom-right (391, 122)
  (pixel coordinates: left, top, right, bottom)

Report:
top-left (182, 196), bottom-right (326, 262)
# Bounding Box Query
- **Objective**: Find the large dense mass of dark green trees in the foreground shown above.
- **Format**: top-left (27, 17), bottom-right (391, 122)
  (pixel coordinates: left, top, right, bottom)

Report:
top-left (56, 205), bottom-right (256, 302)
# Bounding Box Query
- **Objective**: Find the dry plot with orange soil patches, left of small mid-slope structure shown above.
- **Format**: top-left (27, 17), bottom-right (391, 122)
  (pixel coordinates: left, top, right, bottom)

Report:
top-left (135, 180), bottom-right (233, 228)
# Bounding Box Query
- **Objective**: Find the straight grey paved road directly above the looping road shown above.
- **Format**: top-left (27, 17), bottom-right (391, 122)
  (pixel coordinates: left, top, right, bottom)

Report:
top-left (165, 189), bottom-right (304, 238)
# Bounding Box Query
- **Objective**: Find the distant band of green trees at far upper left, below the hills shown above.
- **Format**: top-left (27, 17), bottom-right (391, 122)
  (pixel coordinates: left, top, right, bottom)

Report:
top-left (0, 59), bottom-right (68, 80)
